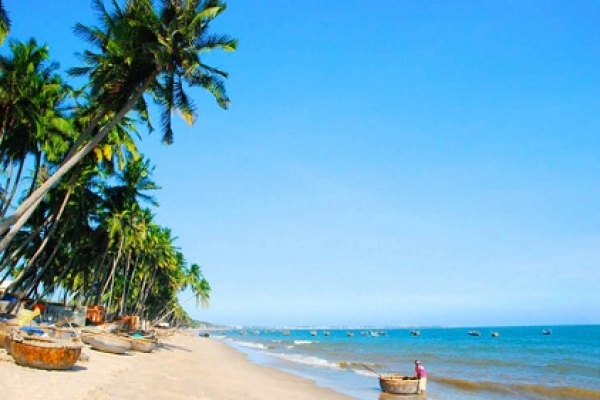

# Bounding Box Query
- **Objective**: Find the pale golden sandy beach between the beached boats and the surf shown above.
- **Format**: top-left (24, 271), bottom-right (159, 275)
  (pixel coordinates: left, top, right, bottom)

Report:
top-left (0, 333), bottom-right (351, 400)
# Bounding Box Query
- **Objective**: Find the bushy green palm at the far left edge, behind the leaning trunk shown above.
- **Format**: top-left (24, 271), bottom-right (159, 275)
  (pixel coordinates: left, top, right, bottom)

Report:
top-left (0, 39), bottom-right (71, 218)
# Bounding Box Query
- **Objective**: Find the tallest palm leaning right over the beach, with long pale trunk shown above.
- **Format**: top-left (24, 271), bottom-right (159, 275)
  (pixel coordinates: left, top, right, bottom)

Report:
top-left (0, 0), bottom-right (237, 252)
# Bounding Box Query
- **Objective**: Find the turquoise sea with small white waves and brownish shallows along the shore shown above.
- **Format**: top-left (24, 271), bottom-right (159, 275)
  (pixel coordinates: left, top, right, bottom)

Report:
top-left (213, 325), bottom-right (600, 400)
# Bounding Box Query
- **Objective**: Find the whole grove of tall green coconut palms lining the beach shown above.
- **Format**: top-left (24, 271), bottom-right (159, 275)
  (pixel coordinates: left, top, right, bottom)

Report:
top-left (0, 0), bottom-right (237, 322)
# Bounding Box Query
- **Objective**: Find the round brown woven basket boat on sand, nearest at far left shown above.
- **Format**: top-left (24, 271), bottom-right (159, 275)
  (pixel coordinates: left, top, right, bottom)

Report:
top-left (8, 334), bottom-right (83, 370)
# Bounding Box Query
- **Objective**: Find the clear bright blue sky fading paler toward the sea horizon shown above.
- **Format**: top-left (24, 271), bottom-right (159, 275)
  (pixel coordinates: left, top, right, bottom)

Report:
top-left (4, 0), bottom-right (600, 326)
